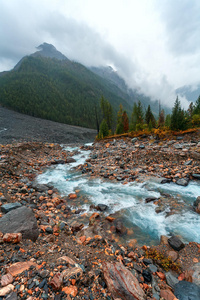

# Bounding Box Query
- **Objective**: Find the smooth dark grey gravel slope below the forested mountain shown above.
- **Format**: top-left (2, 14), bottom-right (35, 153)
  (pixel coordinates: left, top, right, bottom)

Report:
top-left (0, 106), bottom-right (97, 145)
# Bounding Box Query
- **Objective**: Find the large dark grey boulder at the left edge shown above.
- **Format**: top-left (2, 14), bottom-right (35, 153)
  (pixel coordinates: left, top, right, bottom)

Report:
top-left (0, 206), bottom-right (39, 242)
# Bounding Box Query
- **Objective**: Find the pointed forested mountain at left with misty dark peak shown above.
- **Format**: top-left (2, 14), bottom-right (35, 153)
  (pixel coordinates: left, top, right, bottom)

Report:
top-left (0, 43), bottom-right (132, 128)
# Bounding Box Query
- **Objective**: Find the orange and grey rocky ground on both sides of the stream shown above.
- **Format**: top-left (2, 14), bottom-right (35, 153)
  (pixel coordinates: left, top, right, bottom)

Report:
top-left (0, 134), bottom-right (200, 300)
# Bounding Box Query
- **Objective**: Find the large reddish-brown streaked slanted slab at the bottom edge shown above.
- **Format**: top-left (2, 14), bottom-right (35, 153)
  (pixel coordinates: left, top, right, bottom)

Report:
top-left (102, 262), bottom-right (145, 300)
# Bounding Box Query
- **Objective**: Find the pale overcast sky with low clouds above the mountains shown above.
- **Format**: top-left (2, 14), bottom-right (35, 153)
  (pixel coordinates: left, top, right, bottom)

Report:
top-left (0, 0), bottom-right (200, 108)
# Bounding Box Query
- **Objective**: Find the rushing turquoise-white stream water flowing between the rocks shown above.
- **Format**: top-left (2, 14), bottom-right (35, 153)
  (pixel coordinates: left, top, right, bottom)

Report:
top-left (38, 147), bottom-right (200, 244)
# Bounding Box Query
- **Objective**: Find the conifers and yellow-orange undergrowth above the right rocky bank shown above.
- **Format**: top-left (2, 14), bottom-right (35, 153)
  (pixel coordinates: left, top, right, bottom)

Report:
top-left (98, 96), bottom-right (200, 138)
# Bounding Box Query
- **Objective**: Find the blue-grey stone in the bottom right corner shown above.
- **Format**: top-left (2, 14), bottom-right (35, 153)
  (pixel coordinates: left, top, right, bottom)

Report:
top-left (174, 280), bottom-right (200, 300)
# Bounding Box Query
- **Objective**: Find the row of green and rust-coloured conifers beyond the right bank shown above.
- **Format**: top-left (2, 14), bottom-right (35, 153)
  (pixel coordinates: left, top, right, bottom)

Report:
top-left (98, 96), bottom-right (200, 138)
